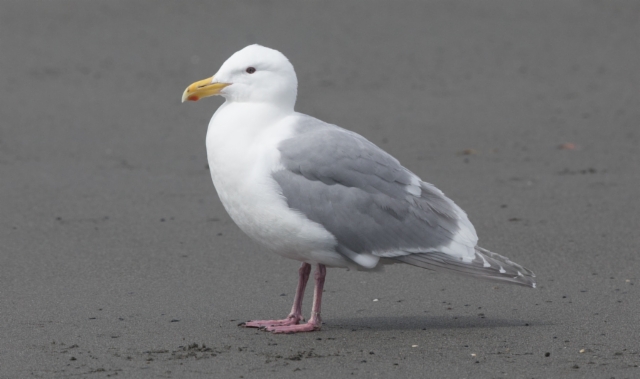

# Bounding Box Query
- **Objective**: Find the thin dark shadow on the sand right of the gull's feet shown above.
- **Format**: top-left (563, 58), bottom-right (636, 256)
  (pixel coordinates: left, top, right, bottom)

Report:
top-left (325, 316), bottom-right (545, 330)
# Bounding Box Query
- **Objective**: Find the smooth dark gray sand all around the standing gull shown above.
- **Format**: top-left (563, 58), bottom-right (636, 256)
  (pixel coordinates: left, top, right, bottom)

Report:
top-left (0, 0), bottom-right (640, 378)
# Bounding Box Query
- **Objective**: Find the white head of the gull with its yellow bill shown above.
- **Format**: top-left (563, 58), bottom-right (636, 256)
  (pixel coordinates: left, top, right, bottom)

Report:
top-left (182, 45), bottom-right (298, 109)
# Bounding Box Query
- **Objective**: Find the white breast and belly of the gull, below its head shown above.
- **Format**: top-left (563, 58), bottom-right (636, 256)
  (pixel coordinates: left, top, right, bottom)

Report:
top-left (207, 103), bottom-right (344, 266)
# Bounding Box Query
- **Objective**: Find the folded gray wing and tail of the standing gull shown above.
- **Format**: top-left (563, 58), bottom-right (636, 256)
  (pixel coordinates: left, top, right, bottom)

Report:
top-left (273, 116), bottom-right (535, 286)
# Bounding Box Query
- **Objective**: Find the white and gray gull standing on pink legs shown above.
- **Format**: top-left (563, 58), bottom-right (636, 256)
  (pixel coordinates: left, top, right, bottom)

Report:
top-left (182, 45), bottom-right (535, 333)
